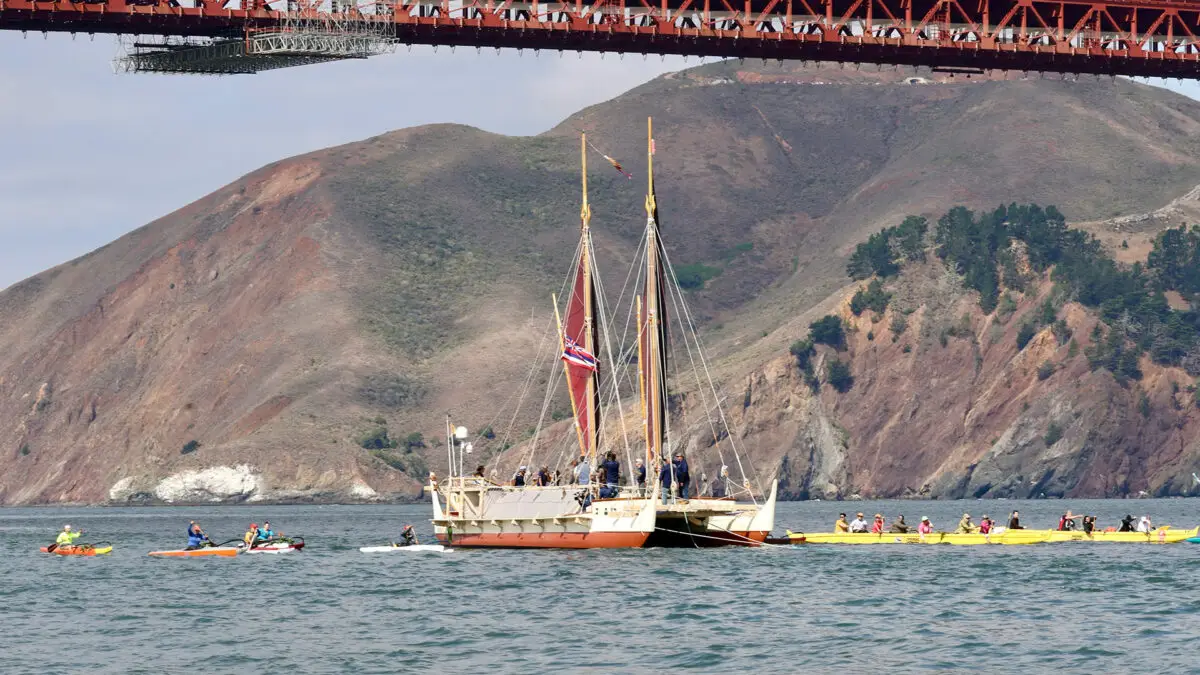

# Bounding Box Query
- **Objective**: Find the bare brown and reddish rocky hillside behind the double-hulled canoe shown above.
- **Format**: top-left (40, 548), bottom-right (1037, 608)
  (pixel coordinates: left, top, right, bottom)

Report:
top-left (0, 64), bottom-right (1200, 504)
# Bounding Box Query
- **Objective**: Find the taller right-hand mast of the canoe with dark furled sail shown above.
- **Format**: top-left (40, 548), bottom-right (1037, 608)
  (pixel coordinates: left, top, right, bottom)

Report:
top-left (638, 119), bottom-right (670, 461)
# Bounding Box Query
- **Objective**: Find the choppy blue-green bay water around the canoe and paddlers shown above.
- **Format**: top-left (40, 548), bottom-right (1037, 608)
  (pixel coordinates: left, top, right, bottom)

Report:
top-left (0, 500), bottom-right (1200, 674)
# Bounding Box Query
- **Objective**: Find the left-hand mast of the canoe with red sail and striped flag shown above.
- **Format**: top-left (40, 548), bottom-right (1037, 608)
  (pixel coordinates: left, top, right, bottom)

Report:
top-left (554, 135), bottom-right (600, 466)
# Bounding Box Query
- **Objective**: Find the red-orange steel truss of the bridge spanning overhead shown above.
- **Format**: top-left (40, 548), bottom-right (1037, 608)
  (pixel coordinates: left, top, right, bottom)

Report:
top-left (0, 0), bottom-right (1200, 78)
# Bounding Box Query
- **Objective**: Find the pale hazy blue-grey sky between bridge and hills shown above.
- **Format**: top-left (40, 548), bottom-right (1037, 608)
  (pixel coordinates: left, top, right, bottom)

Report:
top-left (0, 32), bottom-right (1200, 288)
